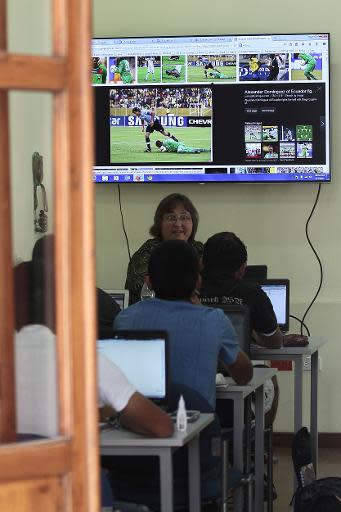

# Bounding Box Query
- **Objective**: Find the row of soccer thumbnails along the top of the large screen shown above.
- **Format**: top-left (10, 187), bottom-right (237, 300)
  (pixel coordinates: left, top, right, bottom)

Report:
top-left (92, 52), bottom-right (323, 85)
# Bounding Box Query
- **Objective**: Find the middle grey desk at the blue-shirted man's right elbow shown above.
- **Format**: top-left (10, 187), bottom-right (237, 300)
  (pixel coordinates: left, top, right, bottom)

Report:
top-left (217, 368), bottom-right (277, 512)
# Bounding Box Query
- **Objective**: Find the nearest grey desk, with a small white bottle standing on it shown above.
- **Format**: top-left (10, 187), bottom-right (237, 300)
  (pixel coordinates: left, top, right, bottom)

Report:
top-left (100, 413), bottom-right (214, 512)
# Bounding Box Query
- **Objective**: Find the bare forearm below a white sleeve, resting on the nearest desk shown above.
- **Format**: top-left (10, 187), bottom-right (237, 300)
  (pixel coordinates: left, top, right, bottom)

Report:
top-left (121, 392), bottom-right (174, 437)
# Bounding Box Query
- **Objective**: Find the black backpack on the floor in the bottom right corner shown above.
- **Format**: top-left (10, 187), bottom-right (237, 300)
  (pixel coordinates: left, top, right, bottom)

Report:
top-left (291, 427), bottom-right (341, 512)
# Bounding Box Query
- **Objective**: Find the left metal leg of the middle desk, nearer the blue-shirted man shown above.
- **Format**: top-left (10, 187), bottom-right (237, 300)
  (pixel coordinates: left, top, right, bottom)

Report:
top-left (233, 397), bottom-right (244, 510)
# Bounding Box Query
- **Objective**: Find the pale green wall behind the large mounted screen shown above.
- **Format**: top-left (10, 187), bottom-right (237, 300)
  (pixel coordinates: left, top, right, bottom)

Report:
top-left (94, 0), bottom-right (341, 432)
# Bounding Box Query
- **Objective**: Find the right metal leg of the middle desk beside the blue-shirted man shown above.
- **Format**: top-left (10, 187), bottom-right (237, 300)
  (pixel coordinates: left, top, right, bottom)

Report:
top-left (255, 386), bottom-right (264, 512)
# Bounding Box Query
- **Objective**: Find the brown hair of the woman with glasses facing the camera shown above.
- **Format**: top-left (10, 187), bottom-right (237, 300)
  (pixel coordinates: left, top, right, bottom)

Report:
top-left (149, 194), bottom-right (199, 241)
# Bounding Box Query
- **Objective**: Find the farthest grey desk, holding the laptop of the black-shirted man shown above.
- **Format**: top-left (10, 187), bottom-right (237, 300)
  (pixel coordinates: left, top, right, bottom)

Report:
top-left (251, 337), bottom-right (327, 480)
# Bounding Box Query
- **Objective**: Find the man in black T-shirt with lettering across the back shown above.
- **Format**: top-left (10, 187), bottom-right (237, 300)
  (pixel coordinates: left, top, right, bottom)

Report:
top-left (200, 231), bottom-right (307, 348)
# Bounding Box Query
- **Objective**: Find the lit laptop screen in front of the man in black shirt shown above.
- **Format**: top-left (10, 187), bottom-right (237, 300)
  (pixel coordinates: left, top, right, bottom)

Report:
top-left (258, 279), bottom-right (290, 332)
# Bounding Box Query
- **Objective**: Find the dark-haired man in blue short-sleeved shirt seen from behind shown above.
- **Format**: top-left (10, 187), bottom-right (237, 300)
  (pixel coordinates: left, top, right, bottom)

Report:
top-left (114, 240), bottom-right (252, 407)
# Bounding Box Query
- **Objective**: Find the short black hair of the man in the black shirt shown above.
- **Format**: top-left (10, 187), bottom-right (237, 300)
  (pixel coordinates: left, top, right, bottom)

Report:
top-left (203, 231), bottom-right (247, 274)
